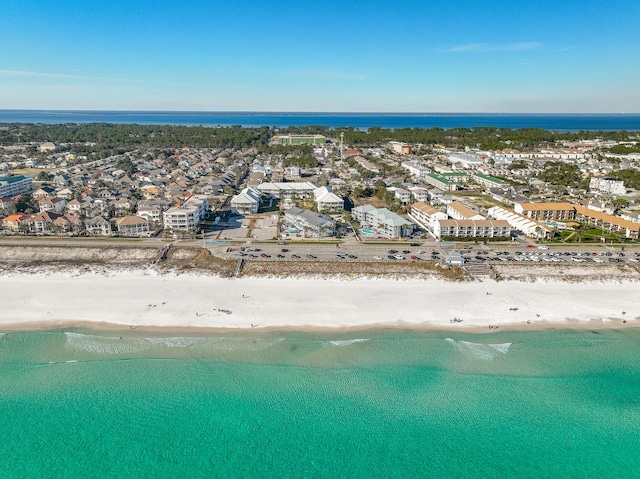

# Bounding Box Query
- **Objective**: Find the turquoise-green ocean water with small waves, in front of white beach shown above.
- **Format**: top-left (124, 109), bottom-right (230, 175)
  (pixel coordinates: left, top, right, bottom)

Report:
top-left (0, 329), bottom-right (640, 478)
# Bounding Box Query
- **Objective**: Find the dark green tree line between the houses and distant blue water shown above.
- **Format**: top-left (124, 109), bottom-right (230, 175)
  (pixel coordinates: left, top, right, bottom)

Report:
top-left (0, 123), bottom-right (637, 153)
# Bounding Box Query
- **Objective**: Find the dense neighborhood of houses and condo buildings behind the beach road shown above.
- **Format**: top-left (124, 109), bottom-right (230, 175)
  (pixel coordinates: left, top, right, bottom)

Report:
top-left (0, 130), bottom-right (640, 241)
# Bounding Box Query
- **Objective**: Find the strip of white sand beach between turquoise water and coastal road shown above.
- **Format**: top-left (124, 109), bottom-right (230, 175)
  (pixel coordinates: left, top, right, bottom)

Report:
top-left (0, 270), bottom-right (640, 330)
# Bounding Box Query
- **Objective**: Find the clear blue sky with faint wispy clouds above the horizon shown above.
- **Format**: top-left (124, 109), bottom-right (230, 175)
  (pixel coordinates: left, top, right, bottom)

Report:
top-left (0, 0), bottom-right (640, 113)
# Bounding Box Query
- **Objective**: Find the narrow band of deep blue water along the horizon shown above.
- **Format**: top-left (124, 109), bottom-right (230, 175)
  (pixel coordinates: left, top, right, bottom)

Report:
top-left (0, 110), bottom-right (640, 132)
